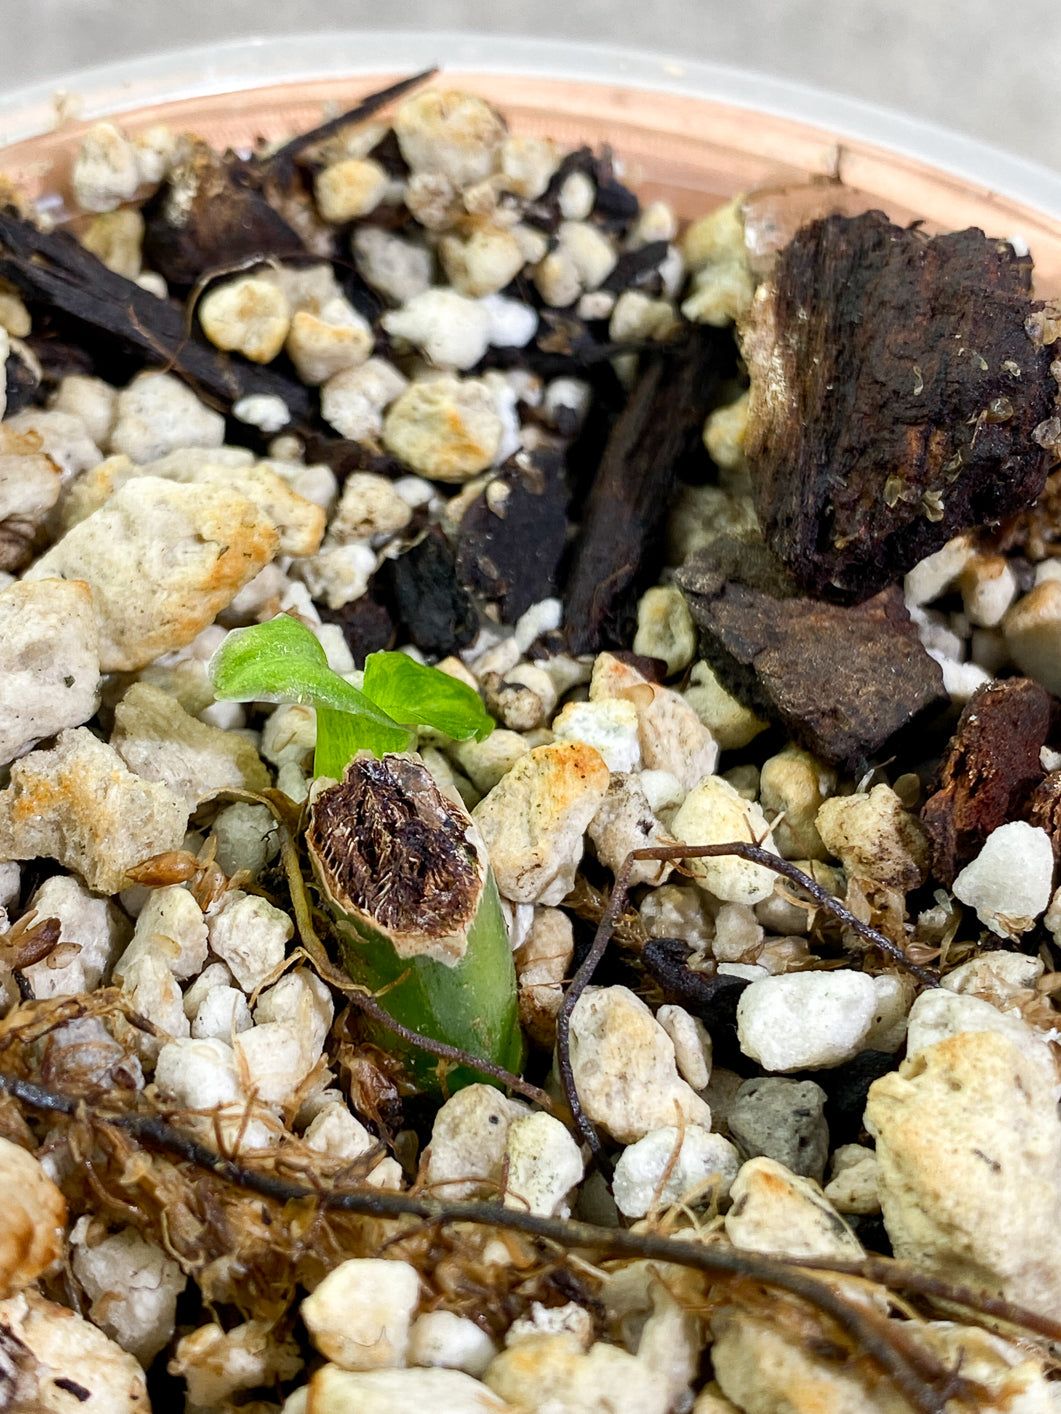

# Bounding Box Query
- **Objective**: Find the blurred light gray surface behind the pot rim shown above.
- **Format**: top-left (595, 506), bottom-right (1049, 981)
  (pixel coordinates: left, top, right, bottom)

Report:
top-left (0, 0), bottom-right (1061, 171)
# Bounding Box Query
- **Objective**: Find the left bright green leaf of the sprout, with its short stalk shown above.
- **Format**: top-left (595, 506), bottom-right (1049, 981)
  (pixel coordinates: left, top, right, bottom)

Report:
top-left (209, 614), bottom-right (418, 778)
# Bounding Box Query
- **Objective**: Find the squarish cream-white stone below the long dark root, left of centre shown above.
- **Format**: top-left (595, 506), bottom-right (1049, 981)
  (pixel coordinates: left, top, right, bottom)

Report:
top-left (298, 1257), bottom-right (420, 1370)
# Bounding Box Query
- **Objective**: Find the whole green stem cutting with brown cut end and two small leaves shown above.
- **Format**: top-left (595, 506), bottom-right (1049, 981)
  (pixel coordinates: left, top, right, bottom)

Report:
top-left (209, 614), bottom-right (522, 1090)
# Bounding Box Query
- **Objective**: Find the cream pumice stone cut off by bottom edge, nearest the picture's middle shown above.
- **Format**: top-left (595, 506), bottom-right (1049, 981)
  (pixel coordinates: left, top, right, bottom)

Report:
top-left (482, 1332), bottom-right (671, 1414)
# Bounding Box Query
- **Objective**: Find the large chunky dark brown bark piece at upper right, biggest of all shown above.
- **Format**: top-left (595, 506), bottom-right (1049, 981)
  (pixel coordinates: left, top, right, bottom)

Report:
top-left (743, 212), bottom-right (1058, 602)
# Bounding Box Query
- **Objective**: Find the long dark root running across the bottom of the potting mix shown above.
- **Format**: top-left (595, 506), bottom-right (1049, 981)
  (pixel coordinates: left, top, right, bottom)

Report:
top-left (0, 1075), bottom-right (1001, 1414)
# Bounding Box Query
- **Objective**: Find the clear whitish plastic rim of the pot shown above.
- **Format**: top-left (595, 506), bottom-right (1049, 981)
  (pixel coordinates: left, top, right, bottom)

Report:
top-left (0, 30), bottom-right (1061, 221)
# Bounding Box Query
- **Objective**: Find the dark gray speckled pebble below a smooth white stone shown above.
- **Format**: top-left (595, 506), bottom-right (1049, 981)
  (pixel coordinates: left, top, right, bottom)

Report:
top-left (729, 1076), bottom-right (829, 1184)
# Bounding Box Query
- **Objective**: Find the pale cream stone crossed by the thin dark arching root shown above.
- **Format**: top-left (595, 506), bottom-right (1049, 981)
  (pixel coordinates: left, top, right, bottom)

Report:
top-left (671, 776), bottom-right (777, 905)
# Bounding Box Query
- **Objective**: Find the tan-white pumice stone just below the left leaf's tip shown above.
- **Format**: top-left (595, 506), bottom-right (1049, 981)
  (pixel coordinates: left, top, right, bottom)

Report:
top-left (110, 683), bottom-right (270, 810)
